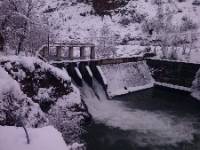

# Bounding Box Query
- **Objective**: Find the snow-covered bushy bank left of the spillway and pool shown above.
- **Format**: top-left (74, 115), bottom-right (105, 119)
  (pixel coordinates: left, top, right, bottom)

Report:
top-left (0, 56), bottom-right (90, 144)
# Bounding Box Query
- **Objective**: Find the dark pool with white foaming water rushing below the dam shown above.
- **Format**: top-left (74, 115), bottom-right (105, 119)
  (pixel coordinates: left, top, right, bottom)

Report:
top-left (80, 81), bottom-right (200, 150)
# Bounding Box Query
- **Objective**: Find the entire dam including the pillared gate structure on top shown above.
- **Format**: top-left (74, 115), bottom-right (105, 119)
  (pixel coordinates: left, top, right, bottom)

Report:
top-left (38, 43), bottom-right (200, 98)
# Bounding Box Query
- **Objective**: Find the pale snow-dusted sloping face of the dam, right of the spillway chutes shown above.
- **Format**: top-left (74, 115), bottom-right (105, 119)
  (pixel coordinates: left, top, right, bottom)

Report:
top-left (101, 62), bottom-right (153, 97)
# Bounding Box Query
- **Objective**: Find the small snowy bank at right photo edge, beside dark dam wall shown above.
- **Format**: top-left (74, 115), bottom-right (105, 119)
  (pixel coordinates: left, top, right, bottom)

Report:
top-left (191, 70), bottom-right (200, 100)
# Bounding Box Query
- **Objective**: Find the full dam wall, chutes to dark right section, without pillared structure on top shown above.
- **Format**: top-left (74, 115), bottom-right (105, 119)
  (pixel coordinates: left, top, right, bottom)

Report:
top-left (51, 58), bottom-right (200, 97)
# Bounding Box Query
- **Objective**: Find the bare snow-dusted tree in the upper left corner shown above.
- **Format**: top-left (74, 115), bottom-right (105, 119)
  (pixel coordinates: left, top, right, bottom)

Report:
top-left (0, 0), bottom-right (48, 54)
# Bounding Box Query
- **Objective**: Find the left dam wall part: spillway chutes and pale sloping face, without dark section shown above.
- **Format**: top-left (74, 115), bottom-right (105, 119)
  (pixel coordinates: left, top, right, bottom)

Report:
top-left (54, 61), bottom-right (154, 97)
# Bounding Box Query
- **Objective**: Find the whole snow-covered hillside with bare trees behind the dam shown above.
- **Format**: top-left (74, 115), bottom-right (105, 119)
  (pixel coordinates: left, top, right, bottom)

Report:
top-left (0, 0), bottom-right (200, 60)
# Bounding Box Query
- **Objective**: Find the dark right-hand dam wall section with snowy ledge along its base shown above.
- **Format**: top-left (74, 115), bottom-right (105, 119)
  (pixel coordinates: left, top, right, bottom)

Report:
top-left (147, 59), bottom-right (200, 92)
